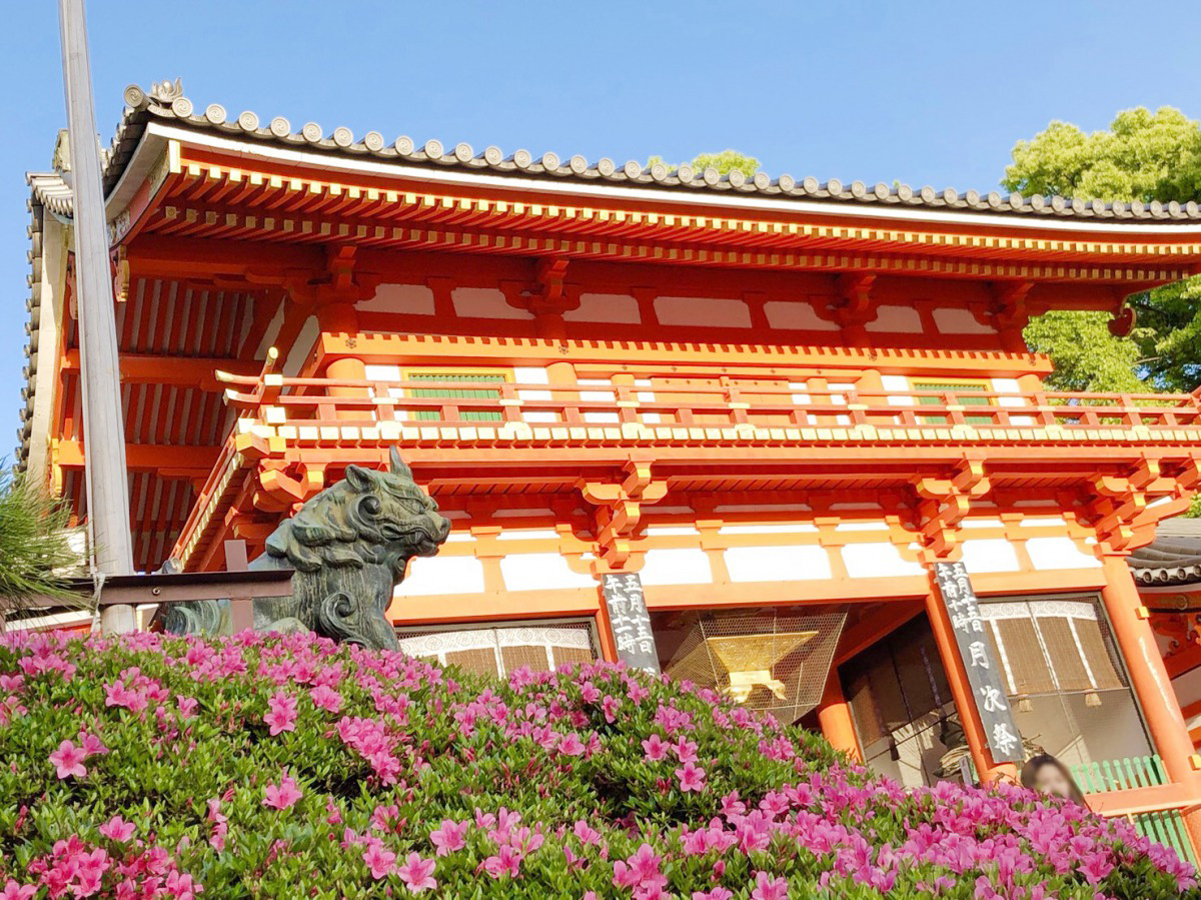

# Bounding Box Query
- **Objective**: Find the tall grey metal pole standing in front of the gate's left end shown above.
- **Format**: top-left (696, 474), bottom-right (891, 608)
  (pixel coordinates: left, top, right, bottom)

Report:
top-left (59, 0), bottom-right (136, 633)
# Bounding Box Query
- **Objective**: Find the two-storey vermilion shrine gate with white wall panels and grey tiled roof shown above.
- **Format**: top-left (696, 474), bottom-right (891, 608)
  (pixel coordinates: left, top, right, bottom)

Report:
top-left (20, 82), bottom-right (1201, 853)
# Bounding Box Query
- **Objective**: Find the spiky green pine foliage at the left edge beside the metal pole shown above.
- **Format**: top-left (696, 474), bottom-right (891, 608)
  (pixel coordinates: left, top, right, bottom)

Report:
top-left (0, 472), bottom-right (80, 627)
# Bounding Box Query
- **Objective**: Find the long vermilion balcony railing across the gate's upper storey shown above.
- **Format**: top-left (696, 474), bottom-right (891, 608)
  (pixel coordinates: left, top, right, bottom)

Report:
top-left (225, 376), bottom-right (1201, 443)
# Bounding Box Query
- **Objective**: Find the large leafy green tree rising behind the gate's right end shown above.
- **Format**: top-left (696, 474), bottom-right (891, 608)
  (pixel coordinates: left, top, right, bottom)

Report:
top-left (1002, 107), bottom-right (1201, 391)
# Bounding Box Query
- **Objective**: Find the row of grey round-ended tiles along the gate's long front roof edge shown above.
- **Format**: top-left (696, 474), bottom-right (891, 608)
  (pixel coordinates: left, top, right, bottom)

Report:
top-left (104, 81), bottom-right (1201, 222)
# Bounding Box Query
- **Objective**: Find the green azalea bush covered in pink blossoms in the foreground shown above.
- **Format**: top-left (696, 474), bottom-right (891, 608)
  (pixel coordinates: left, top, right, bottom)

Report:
top-left (0, 632), bottom-right (1196, 900)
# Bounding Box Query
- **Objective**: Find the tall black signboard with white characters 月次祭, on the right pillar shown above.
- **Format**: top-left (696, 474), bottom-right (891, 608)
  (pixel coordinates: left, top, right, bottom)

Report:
top-left (934, 562), bottom-right (1022, 763)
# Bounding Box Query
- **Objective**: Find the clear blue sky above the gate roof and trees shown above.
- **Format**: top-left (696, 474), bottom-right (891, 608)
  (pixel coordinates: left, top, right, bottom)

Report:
top-left (0, 0), bottom-right (1201, 454)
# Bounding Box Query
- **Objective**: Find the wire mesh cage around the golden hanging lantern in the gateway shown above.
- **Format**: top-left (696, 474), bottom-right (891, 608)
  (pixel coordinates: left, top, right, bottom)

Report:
top-left (656, 609), bottom-right (847, 722)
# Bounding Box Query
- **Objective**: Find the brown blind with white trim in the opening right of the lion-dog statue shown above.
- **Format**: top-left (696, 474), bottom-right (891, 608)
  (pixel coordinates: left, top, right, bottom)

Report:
top-left (396, 621), bottom-right (599, 678)
